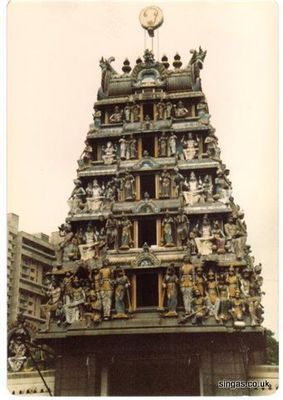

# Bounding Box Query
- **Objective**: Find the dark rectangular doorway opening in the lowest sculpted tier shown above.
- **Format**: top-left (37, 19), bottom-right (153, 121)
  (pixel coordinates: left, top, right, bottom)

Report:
top-left (137, 272), bottom-right (158, 308)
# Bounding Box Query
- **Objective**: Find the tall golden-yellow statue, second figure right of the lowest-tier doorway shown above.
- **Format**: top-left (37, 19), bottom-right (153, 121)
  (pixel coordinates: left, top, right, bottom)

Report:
top-left (180, 256), bottom-right (194, 315)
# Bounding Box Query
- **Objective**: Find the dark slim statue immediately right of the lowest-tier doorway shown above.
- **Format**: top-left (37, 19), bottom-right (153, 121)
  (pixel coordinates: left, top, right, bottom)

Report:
top-left (162, 264), bottom-right (178, 317)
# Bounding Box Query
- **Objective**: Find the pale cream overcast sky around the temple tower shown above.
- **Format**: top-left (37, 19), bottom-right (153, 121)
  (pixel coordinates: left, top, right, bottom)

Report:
top-left (7, 1), bottom-right (278, 332)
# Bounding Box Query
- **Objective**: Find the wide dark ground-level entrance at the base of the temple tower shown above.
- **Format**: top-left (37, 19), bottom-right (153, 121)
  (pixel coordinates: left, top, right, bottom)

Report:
top-left (108, 355), bottom-right (200, 396)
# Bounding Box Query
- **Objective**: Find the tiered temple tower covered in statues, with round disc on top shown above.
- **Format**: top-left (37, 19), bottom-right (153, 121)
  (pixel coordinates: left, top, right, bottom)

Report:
top-left (37, 7), bottom-right (265, 396)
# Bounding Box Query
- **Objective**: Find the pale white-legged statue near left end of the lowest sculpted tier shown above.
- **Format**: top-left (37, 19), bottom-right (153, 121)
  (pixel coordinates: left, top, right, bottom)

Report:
top-left (65, 277), bottom-right (85, 324)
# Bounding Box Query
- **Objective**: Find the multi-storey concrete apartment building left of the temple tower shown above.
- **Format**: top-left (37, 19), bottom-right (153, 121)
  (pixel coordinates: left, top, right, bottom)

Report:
top-left (7, 213), bottom-right (54, 324)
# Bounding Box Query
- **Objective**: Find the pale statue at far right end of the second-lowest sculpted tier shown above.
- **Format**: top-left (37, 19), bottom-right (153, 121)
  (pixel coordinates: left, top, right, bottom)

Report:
top-left (224, 215), bottom-right (247, 259)
